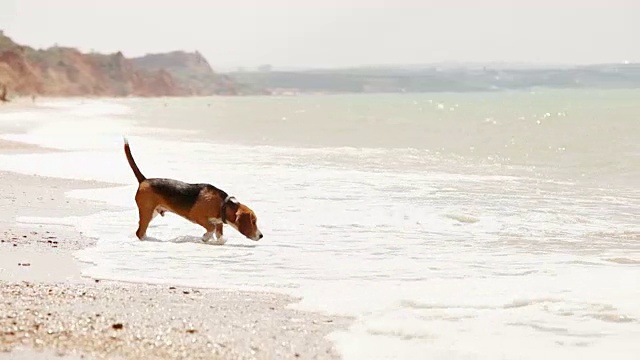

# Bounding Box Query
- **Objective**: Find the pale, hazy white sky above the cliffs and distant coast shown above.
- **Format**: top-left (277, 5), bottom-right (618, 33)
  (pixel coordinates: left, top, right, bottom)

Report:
top-left (0, 0), bottom-right (640, 68)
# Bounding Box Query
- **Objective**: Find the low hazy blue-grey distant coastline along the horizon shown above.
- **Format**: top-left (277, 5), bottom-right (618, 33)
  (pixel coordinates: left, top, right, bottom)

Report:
top-left (225, 64), bottom-right (640, 94)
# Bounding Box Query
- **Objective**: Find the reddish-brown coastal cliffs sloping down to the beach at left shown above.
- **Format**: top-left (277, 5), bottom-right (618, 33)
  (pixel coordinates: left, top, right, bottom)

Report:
top-left (0, 31), bottom-right (239, 97)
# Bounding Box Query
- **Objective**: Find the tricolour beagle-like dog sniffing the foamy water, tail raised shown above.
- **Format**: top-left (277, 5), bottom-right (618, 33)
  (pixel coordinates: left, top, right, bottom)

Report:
top-left (124, 138), bottom-right (263, 245)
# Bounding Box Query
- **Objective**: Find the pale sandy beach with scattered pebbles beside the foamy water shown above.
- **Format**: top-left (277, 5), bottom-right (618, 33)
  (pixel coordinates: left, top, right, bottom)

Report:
top-left (0, 116), bottom-right (348, 359)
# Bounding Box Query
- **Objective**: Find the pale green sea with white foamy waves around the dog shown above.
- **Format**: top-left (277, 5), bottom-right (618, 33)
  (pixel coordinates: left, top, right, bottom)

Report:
top-left (0, 89), bottom-right (640, 360)
